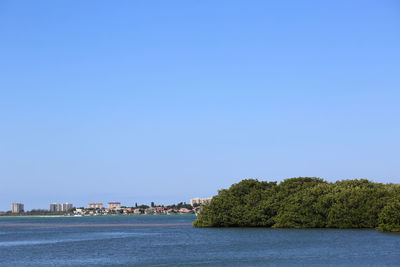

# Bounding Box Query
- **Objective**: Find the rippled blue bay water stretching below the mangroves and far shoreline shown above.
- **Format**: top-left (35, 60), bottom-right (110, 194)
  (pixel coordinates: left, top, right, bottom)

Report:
top-left (0, 215), bottom-right (400, 266)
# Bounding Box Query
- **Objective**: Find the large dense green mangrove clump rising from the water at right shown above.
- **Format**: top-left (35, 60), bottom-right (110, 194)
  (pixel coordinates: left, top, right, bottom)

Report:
top-left (193, 177), bottom-right (400, 232)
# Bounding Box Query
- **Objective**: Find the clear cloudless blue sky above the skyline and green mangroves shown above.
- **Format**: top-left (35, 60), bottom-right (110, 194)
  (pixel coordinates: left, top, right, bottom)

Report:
top-left (0, 0), bottom-right (400, 210)
